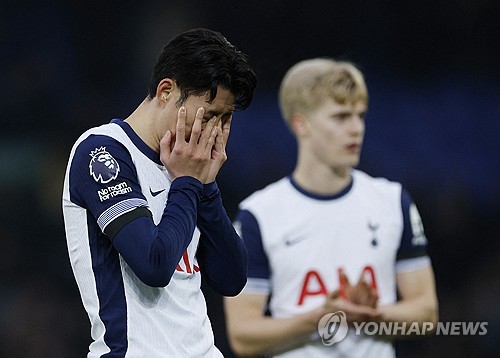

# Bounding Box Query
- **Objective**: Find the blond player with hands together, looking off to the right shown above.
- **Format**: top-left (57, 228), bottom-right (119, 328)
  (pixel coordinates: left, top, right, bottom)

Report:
top-left (224, 58), bottom-right (437, 358)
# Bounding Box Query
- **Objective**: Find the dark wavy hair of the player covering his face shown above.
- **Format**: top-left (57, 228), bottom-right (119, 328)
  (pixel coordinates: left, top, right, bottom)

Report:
top-left (149, 28), bottom-right (257, 110)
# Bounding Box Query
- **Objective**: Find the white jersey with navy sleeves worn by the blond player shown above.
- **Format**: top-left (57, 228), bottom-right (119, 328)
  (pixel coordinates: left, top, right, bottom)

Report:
top-left (235, 170), bottom-right (430, 358)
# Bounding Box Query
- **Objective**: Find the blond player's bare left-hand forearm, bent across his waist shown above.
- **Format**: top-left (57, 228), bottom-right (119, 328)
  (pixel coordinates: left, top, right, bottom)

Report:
top-left (228, 309), bottom-right (325, 356)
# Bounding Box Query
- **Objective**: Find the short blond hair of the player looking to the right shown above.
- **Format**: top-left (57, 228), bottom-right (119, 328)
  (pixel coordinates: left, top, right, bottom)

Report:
top-left (279, 58), bottom-right (368, 122)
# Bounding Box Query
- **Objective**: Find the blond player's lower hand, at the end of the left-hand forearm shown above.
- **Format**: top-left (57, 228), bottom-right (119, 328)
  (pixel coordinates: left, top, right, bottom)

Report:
top-left (323, 290), bottom-right (382, 323)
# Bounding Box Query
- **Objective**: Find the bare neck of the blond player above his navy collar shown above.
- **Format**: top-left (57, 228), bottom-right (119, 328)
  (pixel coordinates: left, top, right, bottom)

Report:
top-left (292, 165), bottom-right (351, 195)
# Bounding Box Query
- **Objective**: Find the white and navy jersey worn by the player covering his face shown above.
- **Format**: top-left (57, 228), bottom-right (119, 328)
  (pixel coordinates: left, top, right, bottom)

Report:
top-left (63, 120), bottom-right (222, 358)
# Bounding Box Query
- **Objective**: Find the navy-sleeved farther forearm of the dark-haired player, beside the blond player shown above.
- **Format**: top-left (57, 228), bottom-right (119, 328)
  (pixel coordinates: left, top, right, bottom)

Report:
top-left (197, 183), bottom-right (248, 296)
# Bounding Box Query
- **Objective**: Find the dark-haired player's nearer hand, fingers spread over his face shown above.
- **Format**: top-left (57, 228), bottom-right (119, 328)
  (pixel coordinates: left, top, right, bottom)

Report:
top-left (160, 107), bottom-right (217, 183)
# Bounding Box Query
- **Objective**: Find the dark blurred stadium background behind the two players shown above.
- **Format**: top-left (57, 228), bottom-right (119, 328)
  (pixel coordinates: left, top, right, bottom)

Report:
top-left (0, 0), bottom-right (500, 358)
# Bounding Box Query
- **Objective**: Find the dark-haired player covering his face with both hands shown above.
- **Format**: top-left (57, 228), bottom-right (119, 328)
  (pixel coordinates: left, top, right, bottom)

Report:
top-left (63, 29), bottom-right (256, 357)
